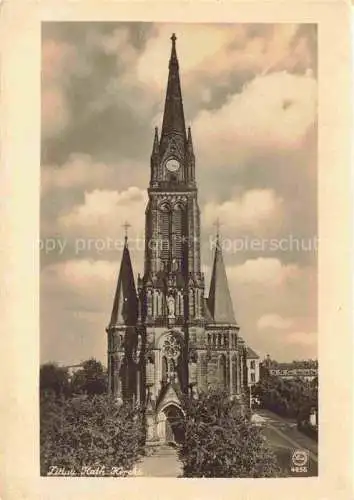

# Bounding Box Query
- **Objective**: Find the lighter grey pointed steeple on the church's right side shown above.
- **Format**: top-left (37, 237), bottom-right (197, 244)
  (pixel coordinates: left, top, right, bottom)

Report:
top-left (208, 230), bottom-right (237, 325)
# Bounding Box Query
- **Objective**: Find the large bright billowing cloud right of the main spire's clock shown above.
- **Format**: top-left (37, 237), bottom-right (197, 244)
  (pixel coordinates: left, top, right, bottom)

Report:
top-left (193, 72), bottom-right (317, 169)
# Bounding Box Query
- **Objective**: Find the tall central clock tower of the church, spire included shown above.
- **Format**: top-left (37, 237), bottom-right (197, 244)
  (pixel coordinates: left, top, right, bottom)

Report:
top-left (138, 35), bottom-right (204, 442)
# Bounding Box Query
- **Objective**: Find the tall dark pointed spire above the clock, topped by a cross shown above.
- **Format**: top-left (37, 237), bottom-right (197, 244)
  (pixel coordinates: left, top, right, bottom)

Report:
top-left (161, 33), bottom-right (186, 141)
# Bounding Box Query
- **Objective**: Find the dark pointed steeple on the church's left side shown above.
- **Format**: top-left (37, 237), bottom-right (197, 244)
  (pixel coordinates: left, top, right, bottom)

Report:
top-left (109, 235), bottom-right (138, 326)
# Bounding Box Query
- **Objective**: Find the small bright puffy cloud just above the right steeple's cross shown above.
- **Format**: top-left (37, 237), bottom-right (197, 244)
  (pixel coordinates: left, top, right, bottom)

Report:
top-left (202, 189), bottom-right (283, 235)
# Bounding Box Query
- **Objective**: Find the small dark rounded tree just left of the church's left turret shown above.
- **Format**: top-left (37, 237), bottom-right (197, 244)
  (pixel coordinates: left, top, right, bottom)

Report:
top-left (71, 358), bottom-right (107, 394)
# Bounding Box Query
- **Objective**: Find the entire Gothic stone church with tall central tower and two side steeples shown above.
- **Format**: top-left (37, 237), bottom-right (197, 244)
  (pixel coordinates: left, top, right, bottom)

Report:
top-left (107, 35), bottom-right (256, 443)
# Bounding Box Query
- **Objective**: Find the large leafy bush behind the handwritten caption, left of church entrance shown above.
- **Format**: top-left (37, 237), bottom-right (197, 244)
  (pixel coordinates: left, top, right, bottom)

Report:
top-left (40, 395), bottom-right (143, 475)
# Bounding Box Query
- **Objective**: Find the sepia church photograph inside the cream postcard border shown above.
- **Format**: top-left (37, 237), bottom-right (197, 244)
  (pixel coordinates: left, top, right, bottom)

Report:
top-left (39, 21), bottom-right (319, 478)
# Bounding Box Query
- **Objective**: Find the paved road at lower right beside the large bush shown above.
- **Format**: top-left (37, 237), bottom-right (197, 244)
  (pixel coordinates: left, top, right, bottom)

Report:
top-left (253, 410), bottom-right (318, 477)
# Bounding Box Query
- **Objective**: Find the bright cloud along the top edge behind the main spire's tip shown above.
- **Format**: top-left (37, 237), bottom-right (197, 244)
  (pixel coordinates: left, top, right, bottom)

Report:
top-left (137, 23), bottom-right (314, 102)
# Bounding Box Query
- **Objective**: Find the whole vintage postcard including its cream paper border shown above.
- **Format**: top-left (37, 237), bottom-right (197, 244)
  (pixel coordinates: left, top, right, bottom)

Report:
top-left (1, 2), bottom-right (352, 499)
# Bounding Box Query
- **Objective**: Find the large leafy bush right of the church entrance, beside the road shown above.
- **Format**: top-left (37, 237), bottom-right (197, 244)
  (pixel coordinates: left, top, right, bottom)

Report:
top-left (180, 392), bottom-right (281, 478)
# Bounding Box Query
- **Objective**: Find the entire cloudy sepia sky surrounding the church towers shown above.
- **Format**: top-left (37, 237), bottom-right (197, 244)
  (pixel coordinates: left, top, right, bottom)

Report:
top-left (41, 22), bottom-right (317, 364)
